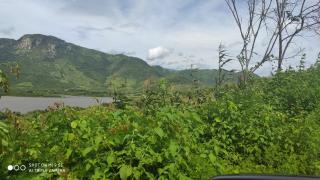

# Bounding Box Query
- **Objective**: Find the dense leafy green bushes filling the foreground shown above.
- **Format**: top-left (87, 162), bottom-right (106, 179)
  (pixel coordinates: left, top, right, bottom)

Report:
top-left (0, 61), bottom-right (320, 179)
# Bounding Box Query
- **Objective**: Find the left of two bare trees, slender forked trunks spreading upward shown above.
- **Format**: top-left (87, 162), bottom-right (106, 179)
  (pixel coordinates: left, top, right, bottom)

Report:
top-left (225, 0), bottom-right (275, 79)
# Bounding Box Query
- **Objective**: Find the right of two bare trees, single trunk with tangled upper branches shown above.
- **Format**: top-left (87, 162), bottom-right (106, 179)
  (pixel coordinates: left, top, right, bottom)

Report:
top-left (270, 0), bottom-right (320, 71)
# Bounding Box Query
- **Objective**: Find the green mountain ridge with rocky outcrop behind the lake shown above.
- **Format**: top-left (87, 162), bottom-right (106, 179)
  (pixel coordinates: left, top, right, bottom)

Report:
top-left (0, 34), bottom-right (237, 94)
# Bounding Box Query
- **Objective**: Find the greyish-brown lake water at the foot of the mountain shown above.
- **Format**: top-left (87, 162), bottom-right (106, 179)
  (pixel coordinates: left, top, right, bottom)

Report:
top-left (0, 96), bottom-right (112, 113)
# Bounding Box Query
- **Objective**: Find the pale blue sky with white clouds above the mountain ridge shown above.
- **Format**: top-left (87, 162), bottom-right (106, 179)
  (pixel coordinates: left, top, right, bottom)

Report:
top-left (0, 0), bottom-right (320, 75)
